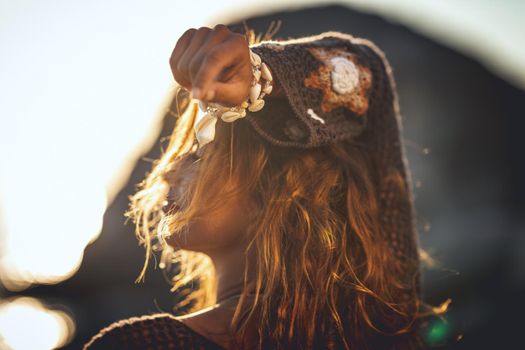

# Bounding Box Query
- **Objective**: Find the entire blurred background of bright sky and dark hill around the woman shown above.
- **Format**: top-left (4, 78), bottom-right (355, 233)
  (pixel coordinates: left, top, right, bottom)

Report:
top-left (0, 0), bottom-right (525, 349)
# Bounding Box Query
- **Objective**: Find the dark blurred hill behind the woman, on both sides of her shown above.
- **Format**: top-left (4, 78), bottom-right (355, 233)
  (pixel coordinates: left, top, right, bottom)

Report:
top-left (3, 5), bottom-right (525, 349)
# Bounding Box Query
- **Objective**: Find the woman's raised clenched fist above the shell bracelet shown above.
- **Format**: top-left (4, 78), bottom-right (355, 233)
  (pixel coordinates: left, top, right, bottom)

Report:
top-left (170, 24), bottom-right (253, 107)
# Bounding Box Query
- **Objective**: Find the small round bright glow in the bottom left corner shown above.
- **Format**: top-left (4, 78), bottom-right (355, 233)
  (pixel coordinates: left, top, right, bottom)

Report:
top-left (0, 298), bottom-right (75, 350)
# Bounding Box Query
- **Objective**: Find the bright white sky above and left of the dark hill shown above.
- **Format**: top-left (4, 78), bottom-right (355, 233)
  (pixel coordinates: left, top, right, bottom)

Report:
top-left (0, 0), bottom-right (525, 346)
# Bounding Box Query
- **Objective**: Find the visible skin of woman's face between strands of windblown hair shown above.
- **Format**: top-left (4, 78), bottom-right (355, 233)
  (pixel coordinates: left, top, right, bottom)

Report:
top-left (167, 151), bottom-right (253, 254)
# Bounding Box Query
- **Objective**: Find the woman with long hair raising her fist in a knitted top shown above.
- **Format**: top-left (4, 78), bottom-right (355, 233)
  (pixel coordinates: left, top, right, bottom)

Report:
top-left (86, 25), bottom-right (422, 349)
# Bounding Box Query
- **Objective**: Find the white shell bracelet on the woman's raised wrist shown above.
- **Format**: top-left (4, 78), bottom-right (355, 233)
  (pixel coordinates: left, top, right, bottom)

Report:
top-left (194, 49), bottom-right (273, 147)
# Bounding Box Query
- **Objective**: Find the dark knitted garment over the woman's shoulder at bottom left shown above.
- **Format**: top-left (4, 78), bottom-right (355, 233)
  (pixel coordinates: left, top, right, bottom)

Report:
top-left (83, 313), bottom-right (223, 350)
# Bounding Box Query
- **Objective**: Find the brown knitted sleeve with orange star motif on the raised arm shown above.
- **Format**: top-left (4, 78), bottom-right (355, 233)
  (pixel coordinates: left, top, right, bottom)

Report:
top-left (246, 31), bottom-right (419, 292)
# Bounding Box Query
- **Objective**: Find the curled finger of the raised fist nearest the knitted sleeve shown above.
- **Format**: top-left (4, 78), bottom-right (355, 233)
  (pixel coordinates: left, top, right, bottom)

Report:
top-left (192, 35), bottom-right (249, 101)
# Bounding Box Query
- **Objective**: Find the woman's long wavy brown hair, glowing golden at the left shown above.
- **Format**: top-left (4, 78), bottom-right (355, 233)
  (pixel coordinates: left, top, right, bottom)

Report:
top-left (126, 23), bottom-right (440, 349)
